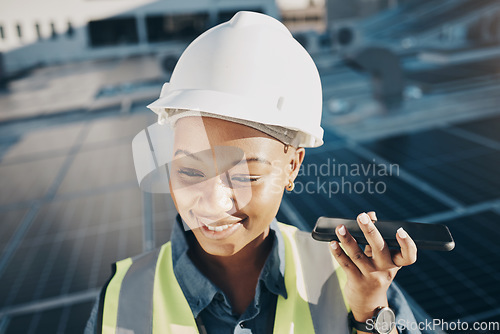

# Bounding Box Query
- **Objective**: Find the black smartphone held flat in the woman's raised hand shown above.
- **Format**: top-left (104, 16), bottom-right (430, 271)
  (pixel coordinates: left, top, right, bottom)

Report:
top-left (312, 217), bottom-right (455, 251)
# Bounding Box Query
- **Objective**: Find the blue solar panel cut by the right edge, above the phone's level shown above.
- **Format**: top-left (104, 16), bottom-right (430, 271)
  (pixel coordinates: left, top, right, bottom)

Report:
top-left (366, 130), bottom-right (500, 204)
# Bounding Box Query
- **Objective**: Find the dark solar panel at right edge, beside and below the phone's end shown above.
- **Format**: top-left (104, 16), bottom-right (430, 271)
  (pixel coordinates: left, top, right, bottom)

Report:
top-left (396, 211), bottom-right (500, 321)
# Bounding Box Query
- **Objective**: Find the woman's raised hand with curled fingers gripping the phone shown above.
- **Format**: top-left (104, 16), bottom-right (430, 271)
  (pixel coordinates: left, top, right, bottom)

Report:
top-left (331, 211), bottom-right (417, 328)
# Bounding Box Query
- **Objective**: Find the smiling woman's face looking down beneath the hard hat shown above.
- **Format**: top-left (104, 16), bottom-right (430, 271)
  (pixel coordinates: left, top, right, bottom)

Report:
top-left (170, 117), bottom-right (304, 256)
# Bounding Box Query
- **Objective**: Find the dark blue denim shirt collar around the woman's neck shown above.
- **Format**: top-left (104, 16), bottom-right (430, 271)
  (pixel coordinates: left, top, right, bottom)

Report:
top-left (171, 215), bottom-right (287, 317)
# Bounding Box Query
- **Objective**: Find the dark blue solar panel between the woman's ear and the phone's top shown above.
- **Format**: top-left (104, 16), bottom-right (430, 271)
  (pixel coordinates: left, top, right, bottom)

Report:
top-left (278, 148), bottom-right (449, 229)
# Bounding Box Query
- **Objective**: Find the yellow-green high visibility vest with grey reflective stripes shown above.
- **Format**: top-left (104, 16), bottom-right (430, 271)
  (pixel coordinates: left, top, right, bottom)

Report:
top-left (98, 223), bottom-right (350, 334)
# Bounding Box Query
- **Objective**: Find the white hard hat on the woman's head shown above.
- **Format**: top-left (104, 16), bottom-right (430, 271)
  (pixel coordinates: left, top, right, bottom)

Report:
top-left (148, 11), bottom-right (323, 147)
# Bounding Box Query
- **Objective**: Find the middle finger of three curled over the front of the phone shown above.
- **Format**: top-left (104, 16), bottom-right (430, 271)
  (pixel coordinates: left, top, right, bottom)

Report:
top-left (357, 212), bottom-right (392, 266)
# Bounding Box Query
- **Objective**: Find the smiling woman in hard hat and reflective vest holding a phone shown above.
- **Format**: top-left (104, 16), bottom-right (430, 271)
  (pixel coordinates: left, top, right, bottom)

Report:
top-left (87, 12), bottom-right (418, 333)
